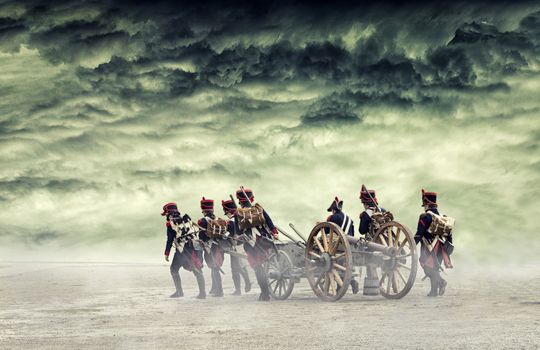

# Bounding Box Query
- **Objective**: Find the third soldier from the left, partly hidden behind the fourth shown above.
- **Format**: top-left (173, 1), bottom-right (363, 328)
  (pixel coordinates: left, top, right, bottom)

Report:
top-left (221, 199), bottom-right (251, 295)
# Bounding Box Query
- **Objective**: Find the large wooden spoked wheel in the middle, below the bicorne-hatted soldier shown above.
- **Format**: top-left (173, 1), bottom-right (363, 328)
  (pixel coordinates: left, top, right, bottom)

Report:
top-left (305, 222), bottom-right (352, 301)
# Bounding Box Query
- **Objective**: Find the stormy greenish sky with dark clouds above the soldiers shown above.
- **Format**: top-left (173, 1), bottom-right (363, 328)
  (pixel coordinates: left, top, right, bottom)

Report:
top-left (0, 1), bottom-right (540, 261)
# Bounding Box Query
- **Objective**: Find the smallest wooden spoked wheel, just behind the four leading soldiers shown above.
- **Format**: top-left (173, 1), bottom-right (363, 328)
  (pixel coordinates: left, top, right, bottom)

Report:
top-left (265, 250), bottom-right (294, 300)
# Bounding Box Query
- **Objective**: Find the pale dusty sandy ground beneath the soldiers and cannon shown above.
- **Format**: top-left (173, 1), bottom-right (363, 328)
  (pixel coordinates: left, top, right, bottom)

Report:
top-left (0, 261), bottom-right (540, 349)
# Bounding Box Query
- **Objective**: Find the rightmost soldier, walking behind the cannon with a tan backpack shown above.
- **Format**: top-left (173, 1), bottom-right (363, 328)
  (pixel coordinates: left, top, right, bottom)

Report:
top-left (414, 189), bottom-right (453, 297)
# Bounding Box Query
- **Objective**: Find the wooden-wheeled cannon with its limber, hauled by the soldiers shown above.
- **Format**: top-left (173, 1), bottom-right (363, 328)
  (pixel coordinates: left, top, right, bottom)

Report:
top-left (266, 220), bottom-right (418, 301)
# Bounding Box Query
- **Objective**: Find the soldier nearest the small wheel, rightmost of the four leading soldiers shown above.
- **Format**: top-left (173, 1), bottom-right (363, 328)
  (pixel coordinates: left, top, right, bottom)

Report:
top-left (236, 187), bottom-right (278, 301)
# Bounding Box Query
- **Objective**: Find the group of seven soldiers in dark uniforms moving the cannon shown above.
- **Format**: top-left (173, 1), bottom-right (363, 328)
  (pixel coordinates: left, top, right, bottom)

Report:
top-left (161, 186), bottom-right (453, 301)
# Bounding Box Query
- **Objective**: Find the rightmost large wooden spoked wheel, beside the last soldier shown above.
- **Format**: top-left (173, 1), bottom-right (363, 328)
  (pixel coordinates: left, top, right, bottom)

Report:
top-left (373, 221), bottom-right (418, 299)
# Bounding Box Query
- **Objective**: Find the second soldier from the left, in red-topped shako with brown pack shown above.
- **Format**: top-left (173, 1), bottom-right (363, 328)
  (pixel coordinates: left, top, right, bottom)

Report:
top-left (197, 197), bottom-right (223, 297)
